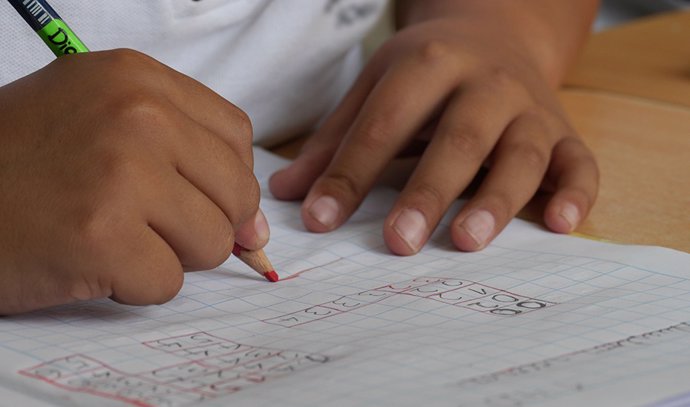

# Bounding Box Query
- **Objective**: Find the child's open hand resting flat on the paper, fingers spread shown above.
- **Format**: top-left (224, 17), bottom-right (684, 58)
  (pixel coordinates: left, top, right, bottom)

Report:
top-left (271, 12), bottom-right (598, 255)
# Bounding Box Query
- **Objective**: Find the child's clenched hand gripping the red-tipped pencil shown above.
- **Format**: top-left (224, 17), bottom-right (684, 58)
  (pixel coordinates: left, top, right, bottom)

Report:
top-left (0, 51), bottom-right (268, 314)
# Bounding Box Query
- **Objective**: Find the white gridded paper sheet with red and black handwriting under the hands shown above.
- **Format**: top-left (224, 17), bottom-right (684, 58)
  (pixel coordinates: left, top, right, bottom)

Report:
top-left (0, 151), bottom-right (690, 407)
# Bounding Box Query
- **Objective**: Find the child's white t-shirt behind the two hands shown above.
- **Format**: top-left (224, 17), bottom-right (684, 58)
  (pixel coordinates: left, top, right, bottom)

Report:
top-left (0, 0), bottom-right (385, 145)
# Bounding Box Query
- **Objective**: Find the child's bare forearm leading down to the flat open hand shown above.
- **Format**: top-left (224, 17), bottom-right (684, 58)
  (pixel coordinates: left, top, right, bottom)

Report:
top-left (395, 0), bottom-right (599, 86)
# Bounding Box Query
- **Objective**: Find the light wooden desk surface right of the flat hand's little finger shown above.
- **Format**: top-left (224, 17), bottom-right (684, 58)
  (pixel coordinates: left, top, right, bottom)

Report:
top-left (560, 90), bottom-right (690, 252)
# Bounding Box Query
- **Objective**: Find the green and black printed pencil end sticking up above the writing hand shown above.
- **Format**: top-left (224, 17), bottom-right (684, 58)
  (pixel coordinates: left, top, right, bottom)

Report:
top-left (7, 0), bottom-right (89, 57)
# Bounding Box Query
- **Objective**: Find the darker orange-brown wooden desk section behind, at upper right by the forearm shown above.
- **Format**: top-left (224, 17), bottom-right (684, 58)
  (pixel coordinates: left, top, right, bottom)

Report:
top-left (565, 11), bottom-right (690, 107)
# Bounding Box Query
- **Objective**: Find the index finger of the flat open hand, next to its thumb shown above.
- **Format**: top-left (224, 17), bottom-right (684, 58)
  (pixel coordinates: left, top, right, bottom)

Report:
top-left (302, 44), bottom-right (458, 232)
